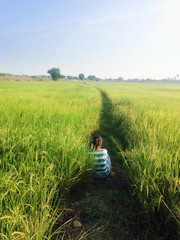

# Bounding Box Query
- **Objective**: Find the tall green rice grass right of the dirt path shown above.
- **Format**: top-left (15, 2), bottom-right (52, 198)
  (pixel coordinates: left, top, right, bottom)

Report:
top-left (99, 84), bottom-right (180, 230)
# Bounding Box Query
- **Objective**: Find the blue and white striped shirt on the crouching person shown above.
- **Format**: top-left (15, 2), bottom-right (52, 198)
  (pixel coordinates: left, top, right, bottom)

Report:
top-left (89, 148), bottom-right (110, 178)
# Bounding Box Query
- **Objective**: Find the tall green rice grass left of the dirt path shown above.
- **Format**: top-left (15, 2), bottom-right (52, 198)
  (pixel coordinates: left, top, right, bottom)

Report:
top-left (0, 82), bottom-right (101, 239)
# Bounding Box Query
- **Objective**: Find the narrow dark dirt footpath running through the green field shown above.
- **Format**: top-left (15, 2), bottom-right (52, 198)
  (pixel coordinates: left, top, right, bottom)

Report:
top-left (55, 90), bottom-right (148, 240)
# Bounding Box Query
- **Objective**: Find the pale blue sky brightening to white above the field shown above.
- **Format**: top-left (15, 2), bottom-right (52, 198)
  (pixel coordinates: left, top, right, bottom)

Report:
top-left (0, 0), bottom-right (180, 79)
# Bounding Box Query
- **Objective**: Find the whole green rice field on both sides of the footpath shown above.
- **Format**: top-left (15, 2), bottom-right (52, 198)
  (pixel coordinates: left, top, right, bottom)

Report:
top-left (0, 82), bottom-right (180, 239)
